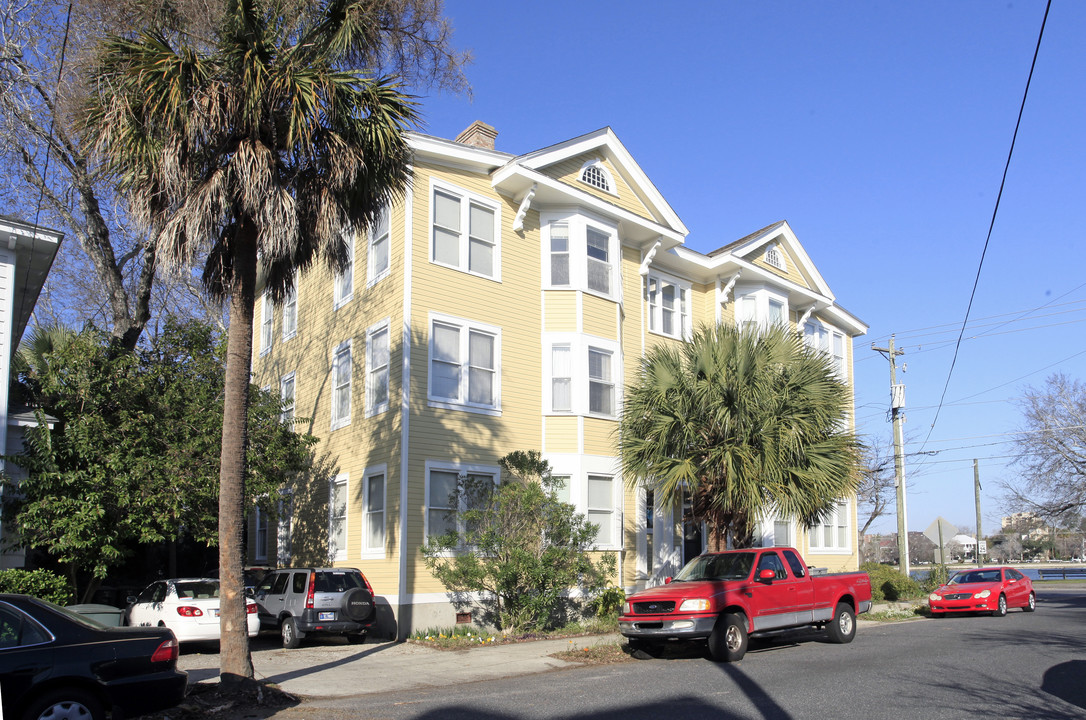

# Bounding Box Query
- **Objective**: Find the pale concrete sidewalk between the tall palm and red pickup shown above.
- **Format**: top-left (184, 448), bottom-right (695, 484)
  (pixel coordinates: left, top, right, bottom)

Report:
top-left (177, 634), bottom-right (622, 697)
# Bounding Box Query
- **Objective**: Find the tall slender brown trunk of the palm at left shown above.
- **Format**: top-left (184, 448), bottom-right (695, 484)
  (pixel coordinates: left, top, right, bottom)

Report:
top-left (218, 220), bottom-right (256, 683)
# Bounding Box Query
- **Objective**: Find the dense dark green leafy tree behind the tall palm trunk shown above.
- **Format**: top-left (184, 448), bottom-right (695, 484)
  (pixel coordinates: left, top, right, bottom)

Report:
top-left (5, 320), bottom-right (315, 599)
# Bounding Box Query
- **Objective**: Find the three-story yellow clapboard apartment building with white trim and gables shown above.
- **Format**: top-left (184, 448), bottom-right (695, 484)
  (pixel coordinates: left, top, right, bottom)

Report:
top-left (248, 123), bottom-right (867, 637)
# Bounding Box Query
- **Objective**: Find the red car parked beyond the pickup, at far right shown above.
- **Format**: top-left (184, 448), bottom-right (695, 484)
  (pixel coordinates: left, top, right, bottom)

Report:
top-left (927, 568), bottom-right (1037, 618)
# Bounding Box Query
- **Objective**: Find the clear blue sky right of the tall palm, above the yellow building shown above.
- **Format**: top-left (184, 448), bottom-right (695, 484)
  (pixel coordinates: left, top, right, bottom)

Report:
top-left (410, 0), bottom-right (1086, 534)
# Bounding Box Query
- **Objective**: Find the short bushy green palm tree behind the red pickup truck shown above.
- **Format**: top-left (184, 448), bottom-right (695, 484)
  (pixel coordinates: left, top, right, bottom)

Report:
top-left (618, 325), bottom-right (859, 551)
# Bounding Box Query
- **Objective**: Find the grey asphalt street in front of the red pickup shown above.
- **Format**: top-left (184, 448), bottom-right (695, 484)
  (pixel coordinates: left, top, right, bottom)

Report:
top-left (274, 584), bottom-right (1086, 720)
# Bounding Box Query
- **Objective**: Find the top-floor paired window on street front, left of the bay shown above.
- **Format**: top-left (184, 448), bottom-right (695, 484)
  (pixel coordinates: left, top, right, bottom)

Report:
top-left (430, 185), bottom-right (502, 280)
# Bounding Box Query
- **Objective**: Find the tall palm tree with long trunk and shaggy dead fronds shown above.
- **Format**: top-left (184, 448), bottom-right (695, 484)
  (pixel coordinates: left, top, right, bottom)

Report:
top-left (84, 0), bottom-right (417, 682)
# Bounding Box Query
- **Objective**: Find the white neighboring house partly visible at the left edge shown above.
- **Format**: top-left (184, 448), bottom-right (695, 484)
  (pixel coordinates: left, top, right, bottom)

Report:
top-left (0, 215), bottom-right (64, 568)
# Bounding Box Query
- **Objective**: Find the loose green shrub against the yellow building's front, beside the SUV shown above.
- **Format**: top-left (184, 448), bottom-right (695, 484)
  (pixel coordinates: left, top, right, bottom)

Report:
top-left (422, 451), bottom-right (615, 630)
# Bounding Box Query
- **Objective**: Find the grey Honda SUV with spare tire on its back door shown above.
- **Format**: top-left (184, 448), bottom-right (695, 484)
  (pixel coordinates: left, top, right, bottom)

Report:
top-left (254, 568), bottom-right (377, 648)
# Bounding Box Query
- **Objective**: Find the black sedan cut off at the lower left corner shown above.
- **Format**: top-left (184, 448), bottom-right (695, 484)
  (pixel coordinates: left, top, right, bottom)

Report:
top-left (0, 594), bottom-right (188, 720)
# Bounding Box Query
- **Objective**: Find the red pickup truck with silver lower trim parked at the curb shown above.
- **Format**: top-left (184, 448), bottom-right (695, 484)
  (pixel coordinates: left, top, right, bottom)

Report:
top-left (618, 547), bottom-right (871, 662)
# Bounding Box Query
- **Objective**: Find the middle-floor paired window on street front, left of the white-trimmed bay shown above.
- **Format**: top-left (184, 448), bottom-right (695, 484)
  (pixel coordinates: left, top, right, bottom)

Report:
top-left (429, 314), bottom-right (501, 412)
